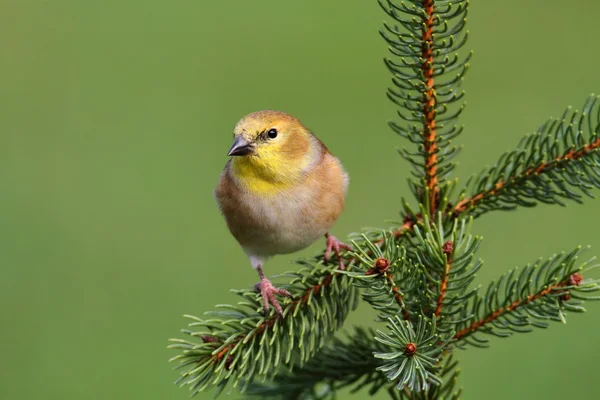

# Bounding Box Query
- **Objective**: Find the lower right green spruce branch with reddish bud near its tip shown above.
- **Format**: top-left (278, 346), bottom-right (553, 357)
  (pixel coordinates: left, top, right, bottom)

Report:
top-left (448, 248), bottom-right (600, 347)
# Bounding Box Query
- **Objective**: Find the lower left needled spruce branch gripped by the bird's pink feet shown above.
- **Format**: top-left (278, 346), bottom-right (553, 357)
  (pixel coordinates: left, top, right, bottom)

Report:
top-left (169, 260), bottom-right (357, 394)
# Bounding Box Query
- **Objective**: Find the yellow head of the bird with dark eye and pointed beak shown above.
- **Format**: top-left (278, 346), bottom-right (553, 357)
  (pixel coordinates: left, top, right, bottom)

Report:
top-left (227, 110), bottom-right (320, 181)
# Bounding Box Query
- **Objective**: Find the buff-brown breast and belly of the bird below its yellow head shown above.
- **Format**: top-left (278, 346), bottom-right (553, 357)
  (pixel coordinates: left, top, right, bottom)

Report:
top-left (215, 155), bottom-right (347, 256)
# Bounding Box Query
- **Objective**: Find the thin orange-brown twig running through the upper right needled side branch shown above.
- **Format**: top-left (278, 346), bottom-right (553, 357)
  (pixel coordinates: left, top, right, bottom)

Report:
top-left (454, 138), bottom-right (600, 214)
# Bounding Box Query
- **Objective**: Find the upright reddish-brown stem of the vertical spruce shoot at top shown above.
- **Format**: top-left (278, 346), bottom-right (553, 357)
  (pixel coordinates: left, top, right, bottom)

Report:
top-left (421, 0), bottom-right (439, 216)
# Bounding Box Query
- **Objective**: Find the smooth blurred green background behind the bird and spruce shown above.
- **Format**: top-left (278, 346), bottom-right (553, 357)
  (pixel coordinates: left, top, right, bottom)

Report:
top-left (0, 0), bottom-right (600, 400)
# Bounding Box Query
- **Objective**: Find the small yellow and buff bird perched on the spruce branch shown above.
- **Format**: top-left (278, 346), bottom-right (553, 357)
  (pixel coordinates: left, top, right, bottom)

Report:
top-left (215, 110), bottom-right (352, 314)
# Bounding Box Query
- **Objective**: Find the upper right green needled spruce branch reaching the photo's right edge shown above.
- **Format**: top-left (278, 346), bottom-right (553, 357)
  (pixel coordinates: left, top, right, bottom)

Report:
top-left (454, 96), bottom-right (600, 216)
